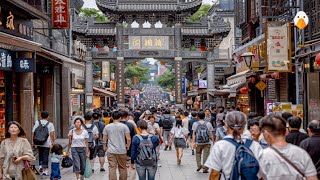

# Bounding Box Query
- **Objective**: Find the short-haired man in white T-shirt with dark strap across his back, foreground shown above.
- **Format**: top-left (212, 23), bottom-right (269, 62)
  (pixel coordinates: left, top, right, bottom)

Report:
top-left (260, 115), bottom-right (318, 180)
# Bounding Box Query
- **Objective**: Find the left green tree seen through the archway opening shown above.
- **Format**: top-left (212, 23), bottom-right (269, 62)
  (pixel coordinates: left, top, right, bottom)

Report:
top-left (124, 64), bottom-right (149, 88)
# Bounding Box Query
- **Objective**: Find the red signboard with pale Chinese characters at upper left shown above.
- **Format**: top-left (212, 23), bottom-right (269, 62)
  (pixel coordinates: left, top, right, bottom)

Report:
top-left (52, 0), bottom-right (70, 29)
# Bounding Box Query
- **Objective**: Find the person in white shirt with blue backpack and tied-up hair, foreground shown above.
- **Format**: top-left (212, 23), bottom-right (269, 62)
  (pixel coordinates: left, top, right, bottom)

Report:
top-left (205, 111), bottom-right (262, 180)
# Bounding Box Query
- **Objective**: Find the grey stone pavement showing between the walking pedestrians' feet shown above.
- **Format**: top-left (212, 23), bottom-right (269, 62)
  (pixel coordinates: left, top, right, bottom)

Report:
top-left (39, 148), bottom-right (209, 180)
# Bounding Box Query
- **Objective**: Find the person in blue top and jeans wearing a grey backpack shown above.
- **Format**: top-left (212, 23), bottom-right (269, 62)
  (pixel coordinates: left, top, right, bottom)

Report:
top-left (131, 120), bottom-right (160, 180)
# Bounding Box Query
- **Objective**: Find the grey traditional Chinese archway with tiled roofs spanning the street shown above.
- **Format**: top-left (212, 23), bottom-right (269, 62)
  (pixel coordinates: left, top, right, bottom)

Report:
top-left (73, 0), bottom-right (230, 107)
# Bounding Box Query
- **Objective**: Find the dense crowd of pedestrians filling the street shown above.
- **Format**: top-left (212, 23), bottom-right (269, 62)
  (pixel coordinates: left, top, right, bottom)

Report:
top-left (0, 85), bottom-right (320, 180)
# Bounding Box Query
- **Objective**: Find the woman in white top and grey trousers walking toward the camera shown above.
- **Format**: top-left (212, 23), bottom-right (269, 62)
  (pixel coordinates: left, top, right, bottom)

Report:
top-left (67, 116), bottom-right (90, 180)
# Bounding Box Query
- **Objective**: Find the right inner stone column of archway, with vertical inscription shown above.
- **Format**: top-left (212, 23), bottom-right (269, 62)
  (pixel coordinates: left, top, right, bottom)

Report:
top-left (174, 23), bottom-right (184, 109)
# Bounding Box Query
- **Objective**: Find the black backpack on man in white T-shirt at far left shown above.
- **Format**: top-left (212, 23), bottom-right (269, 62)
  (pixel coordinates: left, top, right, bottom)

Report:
top-left (33, 120), bottom-right (50, 145)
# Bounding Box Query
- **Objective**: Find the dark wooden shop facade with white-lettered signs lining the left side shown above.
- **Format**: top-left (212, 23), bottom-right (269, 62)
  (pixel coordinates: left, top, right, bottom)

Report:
top-left (0, 0), bottom-right (84, 139)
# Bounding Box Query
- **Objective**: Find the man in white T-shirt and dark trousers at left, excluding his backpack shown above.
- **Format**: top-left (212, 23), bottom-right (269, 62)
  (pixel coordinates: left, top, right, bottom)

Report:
top-left (31, 111), bottom-right (55, 176)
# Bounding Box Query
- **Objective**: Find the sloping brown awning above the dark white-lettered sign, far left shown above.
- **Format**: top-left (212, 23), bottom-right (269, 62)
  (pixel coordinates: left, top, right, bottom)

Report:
top-left (0, 32), bottom-right (41, 51)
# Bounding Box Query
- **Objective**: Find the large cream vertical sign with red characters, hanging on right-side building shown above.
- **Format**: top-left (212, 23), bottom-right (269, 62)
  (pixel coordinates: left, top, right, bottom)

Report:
top-left (266, 22), bottom-right (291, 72)
